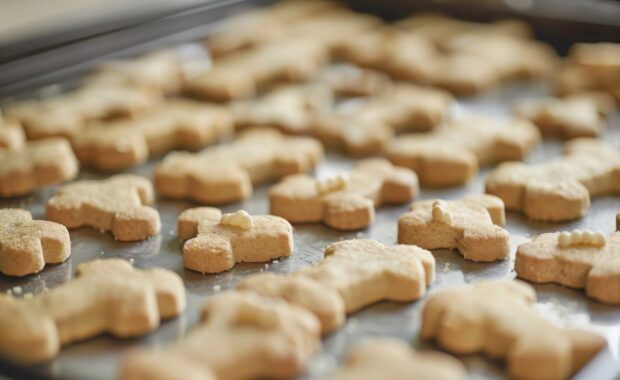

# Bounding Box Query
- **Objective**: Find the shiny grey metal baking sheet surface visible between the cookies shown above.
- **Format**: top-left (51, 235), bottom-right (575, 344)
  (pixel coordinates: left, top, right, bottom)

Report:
top-left (0, 60), bottom-right (620, 380)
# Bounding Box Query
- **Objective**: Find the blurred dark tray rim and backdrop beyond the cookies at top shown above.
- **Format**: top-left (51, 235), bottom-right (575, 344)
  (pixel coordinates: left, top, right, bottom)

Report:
top-left (0, 0), bottom-right (620, 96)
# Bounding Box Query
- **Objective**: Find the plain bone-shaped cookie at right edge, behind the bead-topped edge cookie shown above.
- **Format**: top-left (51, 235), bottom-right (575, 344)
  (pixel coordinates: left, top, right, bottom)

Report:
top-left (486, 138), bottom-right (620, 222)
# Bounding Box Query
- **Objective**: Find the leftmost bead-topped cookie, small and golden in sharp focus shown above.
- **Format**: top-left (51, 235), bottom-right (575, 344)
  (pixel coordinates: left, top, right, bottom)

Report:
top-left (178, 207), bottom-right (293, 273)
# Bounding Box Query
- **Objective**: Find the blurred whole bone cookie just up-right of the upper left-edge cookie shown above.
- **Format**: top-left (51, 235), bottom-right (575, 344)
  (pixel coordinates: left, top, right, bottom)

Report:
top-left (73, 99), bottom-right (233, 171)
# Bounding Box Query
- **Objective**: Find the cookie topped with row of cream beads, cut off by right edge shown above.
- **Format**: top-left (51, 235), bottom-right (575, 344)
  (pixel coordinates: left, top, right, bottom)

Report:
top-left (515, 230), bottom-right (620, 304)
